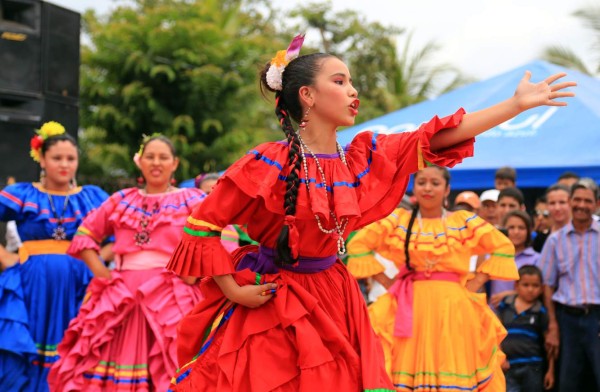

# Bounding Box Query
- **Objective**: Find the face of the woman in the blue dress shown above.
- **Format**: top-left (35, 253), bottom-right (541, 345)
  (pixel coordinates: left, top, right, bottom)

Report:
top-left (40, 140), bottom-right (79, 190)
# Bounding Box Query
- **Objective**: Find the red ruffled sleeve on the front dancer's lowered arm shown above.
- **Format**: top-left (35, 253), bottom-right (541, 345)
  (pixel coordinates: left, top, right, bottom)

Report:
top-left (167, 177), bottom-right (256, 277)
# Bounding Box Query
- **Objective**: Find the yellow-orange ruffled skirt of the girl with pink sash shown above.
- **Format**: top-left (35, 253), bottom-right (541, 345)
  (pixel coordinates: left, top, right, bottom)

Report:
top-left (369, 280), bottom-right (506, 392)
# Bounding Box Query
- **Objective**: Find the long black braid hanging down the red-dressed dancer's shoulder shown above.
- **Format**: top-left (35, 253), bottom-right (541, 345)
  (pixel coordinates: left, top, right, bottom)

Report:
top-left (275, 92), bottom-right (302, 264)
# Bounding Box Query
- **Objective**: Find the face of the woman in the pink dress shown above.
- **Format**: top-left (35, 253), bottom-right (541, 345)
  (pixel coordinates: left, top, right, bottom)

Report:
top-left (140, 140), bottom-right (179, 189)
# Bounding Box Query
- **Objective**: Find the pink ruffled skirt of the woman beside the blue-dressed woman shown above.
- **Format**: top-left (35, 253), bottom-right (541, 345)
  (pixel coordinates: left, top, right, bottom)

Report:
top-left (48, 268), bottom-right (201, 391)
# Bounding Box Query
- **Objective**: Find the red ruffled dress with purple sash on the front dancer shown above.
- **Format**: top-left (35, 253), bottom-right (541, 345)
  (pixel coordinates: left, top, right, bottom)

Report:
top-left (167, 109), bottom-right (474, 392)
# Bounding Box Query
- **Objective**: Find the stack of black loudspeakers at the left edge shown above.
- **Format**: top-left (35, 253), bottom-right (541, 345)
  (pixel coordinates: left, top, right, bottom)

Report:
top-left (0, 0), bottom-right (81, 183)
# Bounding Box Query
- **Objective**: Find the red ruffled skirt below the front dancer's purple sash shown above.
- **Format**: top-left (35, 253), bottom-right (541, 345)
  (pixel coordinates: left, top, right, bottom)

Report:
top-left (170, 250), bottom-right (393, 392)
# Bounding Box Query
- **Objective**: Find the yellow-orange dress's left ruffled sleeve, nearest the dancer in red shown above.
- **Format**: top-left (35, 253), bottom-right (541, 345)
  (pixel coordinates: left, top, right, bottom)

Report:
top-left (346, 210), bottom-right (402, 279)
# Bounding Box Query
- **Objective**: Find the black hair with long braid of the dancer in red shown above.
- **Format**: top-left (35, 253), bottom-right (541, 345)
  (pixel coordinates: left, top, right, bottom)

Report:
top-left (260, 53), bottom-right (333, 265)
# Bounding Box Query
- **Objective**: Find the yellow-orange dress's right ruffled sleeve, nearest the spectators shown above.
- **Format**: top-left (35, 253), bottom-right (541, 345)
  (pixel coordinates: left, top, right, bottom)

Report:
top-left (468, 216), bottom-right (519, 280)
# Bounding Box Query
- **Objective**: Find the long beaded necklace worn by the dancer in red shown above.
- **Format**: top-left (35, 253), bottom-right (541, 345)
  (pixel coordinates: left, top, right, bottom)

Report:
top-left (298, 134), bottom-right (348, 254)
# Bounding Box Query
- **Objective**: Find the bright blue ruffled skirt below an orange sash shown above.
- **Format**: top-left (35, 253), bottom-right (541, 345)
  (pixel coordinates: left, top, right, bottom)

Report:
top-left (0, 255), bottom-right (92, 391)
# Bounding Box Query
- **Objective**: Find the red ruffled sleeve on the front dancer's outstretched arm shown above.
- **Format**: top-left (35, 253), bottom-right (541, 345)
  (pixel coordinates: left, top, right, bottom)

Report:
top-left (348, 109), bottom-right (475, 227)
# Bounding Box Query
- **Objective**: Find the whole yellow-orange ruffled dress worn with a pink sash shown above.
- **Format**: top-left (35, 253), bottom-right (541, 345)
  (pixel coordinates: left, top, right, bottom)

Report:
top-left (348, 209), bottom-right (519, 392)
